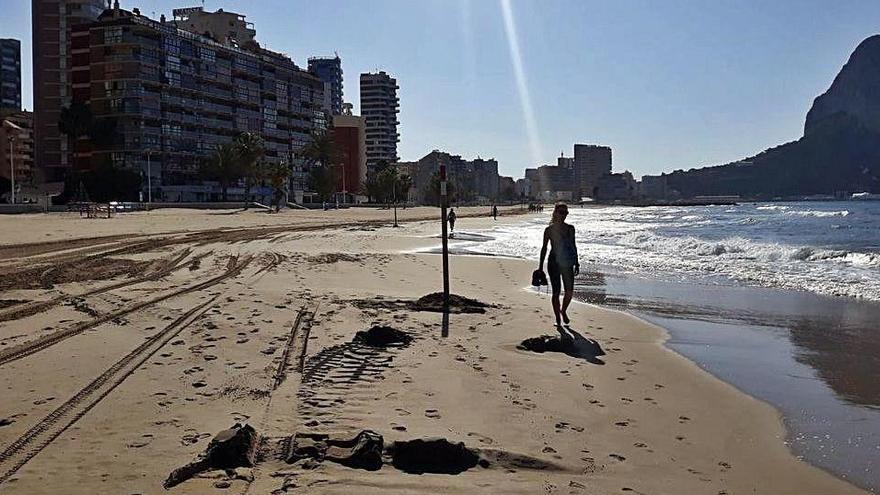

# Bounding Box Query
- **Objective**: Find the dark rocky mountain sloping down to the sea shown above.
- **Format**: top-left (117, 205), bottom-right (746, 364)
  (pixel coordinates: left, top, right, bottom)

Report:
top-left (667, 35), bottom-right (880, 197)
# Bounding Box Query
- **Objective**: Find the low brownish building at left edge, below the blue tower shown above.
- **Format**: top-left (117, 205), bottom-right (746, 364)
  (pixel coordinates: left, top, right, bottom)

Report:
top-left (0, 110), bottom-right (34, 202)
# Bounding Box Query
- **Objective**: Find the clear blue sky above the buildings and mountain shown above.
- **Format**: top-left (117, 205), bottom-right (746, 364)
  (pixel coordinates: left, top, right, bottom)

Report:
top-left (0, 0), bottom-right (880, 177)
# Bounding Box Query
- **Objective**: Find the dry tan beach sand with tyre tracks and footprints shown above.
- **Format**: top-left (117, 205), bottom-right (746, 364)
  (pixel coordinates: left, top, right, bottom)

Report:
top-left (0, 209), bottom-right (859, 494)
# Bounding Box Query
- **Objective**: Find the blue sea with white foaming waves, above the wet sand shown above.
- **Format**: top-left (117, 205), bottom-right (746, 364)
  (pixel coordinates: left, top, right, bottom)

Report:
top-left (472, 203), bottom-right (880, 301)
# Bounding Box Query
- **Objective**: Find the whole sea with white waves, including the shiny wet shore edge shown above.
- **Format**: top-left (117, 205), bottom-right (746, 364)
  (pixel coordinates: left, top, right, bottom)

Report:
top-left (453, 201), bottom-right (880, 492)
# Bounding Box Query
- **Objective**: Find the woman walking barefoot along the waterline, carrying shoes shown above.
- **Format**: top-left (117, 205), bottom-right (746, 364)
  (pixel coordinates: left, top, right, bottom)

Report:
top-left (538, 203), bottom-right (580, 328)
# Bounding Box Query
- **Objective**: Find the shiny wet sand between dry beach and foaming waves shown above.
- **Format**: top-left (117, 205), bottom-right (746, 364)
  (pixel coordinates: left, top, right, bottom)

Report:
top-left (578, 267), bottom-right (880, 492)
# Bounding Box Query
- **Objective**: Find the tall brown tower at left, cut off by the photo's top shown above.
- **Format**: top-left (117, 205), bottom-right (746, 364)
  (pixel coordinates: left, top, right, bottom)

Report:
top-left (31, 0), bottom-right (106, 186)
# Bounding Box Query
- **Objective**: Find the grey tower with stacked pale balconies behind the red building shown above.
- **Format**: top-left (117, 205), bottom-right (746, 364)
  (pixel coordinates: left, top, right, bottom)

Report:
top-left (360, 71), bottom-right (400, 171)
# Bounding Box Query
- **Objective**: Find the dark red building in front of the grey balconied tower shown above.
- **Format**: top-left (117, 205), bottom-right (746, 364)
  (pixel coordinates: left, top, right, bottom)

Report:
top-left (333, 103), bottom-right (367, 202)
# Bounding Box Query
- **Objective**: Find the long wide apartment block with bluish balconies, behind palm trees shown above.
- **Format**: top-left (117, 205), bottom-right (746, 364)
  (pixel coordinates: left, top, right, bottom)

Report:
top-left (70, 8), bottom-right (326, 201)
